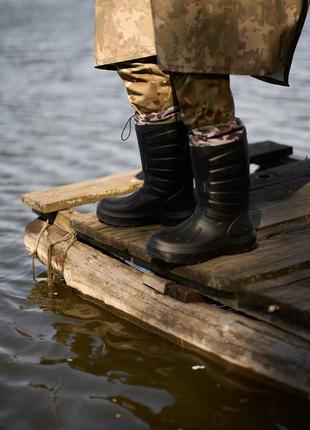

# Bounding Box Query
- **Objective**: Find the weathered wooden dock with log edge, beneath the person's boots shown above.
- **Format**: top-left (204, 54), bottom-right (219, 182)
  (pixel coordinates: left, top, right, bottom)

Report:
top-left (22, 142), bottom-right (310, 396)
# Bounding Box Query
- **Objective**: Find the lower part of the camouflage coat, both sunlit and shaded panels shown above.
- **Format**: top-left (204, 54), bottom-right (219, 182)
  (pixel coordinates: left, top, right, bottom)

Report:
top-left (95, 0), bottom-right (309, 85)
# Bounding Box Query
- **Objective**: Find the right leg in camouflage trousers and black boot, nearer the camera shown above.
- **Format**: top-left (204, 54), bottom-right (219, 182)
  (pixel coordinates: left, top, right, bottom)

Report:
top-left (147, 74), bottom-right (256, 264)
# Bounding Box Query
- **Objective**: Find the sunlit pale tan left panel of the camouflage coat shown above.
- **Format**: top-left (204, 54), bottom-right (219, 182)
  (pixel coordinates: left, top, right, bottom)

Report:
top-left (94, 0), bottom-right (156, 68)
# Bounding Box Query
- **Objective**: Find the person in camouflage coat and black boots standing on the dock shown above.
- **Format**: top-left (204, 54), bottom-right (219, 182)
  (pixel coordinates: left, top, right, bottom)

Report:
top-left (95, 0), bottom-right (309, 264)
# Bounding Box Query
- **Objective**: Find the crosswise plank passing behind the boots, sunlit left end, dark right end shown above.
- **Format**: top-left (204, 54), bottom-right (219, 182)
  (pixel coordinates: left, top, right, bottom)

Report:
top-left (22, 142), bottom-right (292, 214)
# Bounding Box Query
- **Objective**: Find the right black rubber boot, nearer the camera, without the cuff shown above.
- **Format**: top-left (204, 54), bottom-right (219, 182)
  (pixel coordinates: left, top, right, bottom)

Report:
top-left (147, 136), bottom-right (257, 264)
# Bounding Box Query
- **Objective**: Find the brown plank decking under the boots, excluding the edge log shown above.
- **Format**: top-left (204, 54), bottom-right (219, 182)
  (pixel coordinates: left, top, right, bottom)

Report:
top-left (47, 177), bottom-right (310, 338)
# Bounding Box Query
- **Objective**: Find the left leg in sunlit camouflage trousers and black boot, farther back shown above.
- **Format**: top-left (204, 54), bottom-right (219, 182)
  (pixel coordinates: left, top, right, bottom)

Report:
top-left (97, 62), bottom-right (195, 226)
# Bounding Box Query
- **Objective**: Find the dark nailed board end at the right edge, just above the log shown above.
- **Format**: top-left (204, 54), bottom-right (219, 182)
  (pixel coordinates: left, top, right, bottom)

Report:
top-left (237, 269), bottom-right (310, 329)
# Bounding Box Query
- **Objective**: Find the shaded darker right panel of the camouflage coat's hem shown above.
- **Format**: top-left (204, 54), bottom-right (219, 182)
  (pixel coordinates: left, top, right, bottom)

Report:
top-left (152, 0), bottom-right (308, 84)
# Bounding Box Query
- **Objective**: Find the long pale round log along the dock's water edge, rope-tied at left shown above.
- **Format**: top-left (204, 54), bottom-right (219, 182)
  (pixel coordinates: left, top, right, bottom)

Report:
top-left (25, 220), bottom-right (310, 393)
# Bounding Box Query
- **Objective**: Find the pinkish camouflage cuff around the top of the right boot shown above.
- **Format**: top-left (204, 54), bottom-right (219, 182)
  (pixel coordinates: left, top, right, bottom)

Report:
top-left (189, 118), bottom-right (246, 147)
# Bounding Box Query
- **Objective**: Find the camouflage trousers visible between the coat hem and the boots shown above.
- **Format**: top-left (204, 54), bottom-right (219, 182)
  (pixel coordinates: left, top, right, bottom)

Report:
top-left (118, 62), bottom-right (244, 146)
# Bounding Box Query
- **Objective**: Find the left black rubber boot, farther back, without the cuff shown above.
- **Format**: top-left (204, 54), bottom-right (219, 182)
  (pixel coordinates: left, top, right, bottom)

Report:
top-left (97, 122), bottom-right (196, 226)
